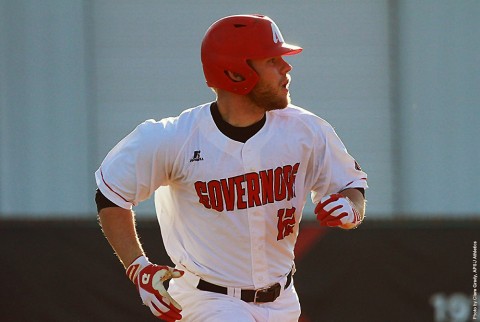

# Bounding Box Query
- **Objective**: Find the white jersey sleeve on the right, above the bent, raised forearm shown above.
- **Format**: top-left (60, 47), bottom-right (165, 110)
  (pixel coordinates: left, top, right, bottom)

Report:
top-left (312, 122), bottom-right (368, 204)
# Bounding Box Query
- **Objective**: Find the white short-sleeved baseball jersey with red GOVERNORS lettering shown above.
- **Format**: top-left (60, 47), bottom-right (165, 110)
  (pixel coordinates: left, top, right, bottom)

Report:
top-left (95, 103), bottom-right (367, 288)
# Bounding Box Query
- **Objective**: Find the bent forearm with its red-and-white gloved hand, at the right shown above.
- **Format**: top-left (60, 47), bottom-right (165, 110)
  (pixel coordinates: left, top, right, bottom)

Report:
top-left (315, 188), bottom-right (365, 229)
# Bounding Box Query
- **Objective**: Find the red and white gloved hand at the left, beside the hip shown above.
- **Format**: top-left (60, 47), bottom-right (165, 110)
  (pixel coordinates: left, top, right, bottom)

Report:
top-left (127, 256), bottom-right (184, 322)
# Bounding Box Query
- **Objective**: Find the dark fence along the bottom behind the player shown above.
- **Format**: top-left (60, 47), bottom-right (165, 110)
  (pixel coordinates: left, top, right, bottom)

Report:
top-left (0, 219), bottom-right (480, 322)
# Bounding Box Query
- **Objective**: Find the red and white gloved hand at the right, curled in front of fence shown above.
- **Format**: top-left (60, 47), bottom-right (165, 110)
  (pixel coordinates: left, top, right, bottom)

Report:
top-left (315, 193), bottom-right (361, 229)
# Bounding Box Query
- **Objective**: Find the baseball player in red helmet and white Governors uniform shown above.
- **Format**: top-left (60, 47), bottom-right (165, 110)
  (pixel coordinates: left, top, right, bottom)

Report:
top-left (95, 15), bottom-right (367, 322)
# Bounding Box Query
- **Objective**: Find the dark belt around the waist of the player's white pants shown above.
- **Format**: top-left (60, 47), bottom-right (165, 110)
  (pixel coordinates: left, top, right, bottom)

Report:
top-left (197, 271), bottom-right (292, 303)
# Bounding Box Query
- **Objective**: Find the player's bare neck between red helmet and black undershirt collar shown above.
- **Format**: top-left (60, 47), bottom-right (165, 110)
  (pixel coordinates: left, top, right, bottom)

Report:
top-left (217, 94), bottom-right (265, 127)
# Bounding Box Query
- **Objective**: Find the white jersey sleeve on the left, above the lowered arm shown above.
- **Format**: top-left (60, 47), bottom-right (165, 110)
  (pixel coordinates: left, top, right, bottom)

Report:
top-left (95, 120), bottom-right (170, 209)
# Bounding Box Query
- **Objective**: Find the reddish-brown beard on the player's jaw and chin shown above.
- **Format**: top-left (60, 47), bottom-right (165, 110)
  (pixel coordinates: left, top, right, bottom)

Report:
top-left (247, 76), bottom-right (291, 111)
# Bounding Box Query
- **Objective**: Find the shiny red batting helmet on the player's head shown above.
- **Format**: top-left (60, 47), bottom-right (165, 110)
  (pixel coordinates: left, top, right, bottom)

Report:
top-left (201, 15), bottom-right (302, 95)
